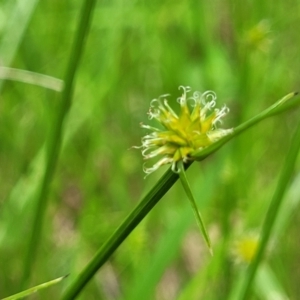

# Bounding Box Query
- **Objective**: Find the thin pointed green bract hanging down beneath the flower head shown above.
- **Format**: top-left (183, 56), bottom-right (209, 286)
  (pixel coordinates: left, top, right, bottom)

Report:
top-left (177, 160), bottom-right (213, 255)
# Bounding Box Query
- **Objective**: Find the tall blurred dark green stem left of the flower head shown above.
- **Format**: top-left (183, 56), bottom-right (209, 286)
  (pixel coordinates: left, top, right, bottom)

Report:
top-left (21, 0), bottom-right (96, 288)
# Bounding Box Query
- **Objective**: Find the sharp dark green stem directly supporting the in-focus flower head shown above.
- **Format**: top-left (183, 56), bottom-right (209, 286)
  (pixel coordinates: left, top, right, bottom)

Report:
top-left (62, 165), bottom-right (189, 300)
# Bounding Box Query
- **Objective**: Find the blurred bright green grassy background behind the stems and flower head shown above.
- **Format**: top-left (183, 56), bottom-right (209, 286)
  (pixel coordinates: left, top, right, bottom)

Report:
top-left (0, 0), bottom-right (300, 300)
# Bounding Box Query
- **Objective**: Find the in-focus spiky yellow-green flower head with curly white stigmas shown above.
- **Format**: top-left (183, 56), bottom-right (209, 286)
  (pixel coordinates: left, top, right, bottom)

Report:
top-left (139, 86), bottom-right (232, 174)
